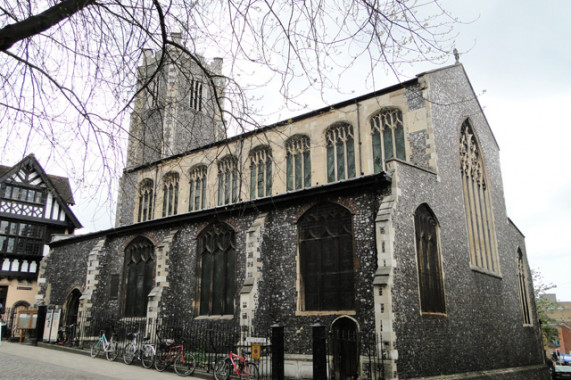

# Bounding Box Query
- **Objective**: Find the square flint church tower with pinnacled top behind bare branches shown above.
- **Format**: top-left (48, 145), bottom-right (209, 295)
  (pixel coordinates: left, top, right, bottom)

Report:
top-left (126, 33), bottom-right (226, 169)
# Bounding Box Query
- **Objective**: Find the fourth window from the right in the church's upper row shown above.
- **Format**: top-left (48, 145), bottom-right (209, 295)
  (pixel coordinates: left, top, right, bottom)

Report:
top-left (250, 147), bottom-right (272, 199)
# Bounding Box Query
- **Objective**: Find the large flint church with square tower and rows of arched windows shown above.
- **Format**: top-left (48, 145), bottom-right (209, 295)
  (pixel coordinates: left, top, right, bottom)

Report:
top-left (38, 42), bottom-right (548, 379)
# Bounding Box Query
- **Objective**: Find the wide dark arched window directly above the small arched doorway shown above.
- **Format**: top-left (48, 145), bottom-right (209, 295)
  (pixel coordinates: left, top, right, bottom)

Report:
top-left (298, 203), bottom-right (355, 311)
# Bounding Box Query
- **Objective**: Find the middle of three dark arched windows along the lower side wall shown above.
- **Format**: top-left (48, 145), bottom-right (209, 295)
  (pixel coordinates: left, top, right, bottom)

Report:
top-left (197, 223), bottom-right (236, 315)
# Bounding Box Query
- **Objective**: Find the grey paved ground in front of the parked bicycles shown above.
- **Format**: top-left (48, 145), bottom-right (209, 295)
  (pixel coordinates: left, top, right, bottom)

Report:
top-left (0, 340), bottom-right (211, 380)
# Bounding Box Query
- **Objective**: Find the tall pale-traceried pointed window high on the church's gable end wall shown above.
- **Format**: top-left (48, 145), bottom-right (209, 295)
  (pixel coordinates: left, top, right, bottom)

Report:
top-left (460, 119), bottom-right (500, 274)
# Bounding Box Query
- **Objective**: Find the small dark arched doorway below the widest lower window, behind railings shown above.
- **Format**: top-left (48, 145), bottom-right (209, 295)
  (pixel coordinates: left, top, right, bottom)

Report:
top-left (331, 317), bottom-right (359, 380)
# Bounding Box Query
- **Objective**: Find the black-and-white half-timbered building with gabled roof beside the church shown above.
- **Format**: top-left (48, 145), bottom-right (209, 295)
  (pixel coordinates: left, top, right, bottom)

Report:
top-left (0, 154), bottom-right (81, 317)
